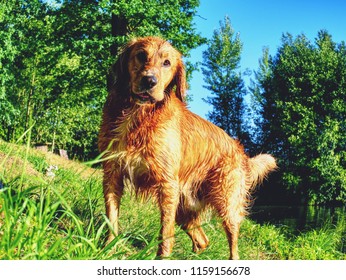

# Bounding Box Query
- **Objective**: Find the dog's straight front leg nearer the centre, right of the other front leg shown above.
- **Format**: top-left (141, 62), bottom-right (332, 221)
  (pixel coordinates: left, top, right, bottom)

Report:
top-left (157, 182), bottom-right (179, 258)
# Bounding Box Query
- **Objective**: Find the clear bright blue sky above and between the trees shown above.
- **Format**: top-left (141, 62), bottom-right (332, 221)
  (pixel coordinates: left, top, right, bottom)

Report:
top-left (189, 0), bottom-right (346, 117)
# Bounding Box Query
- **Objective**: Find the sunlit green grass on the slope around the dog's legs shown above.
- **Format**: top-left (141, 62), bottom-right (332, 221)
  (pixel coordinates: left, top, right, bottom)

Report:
top-left (0, 141), bottom-right (346, 260)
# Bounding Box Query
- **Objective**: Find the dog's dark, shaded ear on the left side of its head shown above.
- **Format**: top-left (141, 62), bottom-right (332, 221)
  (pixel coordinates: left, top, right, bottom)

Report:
top-left (107, 40), bottom-right (136, 91)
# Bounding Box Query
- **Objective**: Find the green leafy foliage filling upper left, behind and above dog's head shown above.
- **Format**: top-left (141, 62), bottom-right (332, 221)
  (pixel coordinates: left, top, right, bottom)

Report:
top-left (0, 0), bottom-right (203, 159)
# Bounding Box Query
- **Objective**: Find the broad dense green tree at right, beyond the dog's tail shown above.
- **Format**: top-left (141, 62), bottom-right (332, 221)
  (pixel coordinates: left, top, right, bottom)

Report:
top-left (252, 31), bottom-right (346, 203)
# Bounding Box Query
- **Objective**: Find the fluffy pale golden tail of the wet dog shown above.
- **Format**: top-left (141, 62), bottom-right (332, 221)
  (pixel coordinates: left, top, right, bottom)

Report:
top-left (249, 154), bottom-right (277, 187)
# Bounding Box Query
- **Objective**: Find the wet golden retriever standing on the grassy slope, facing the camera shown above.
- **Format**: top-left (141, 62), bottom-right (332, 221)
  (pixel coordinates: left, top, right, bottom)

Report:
top-left (98, 37), bottom-right (276, 259)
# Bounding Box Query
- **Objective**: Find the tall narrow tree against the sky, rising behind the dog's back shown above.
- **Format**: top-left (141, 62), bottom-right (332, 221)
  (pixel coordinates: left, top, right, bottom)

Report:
top-left (202, 17), bottom-right (247, 139)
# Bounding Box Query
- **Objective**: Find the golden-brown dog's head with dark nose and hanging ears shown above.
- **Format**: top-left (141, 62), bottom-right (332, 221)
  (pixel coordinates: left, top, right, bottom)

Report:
top-left (111, 37), bottom-right (186, 104)
